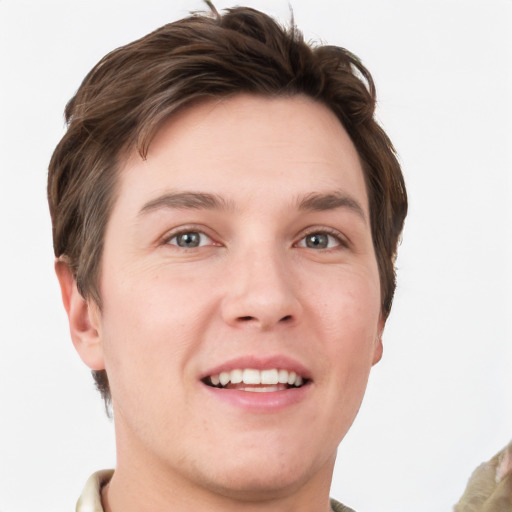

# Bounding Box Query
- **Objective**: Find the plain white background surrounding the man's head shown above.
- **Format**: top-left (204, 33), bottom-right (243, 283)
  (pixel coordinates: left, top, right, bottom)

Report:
top-left (0, 0), bottom-right (512, 512)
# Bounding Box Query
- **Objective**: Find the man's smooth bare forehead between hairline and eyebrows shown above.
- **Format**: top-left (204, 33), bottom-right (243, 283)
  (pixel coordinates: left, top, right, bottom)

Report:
top-left (115, 95), bottom-right (367, 214)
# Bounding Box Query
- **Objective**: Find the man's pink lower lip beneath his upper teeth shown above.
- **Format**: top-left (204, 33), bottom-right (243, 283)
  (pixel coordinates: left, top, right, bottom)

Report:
top-left (203, 383), bottom-right (311, 413)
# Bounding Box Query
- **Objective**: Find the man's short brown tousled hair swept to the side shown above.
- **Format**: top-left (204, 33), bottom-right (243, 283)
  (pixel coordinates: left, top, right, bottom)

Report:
top-left (48, 7), bottom-right (407, 402)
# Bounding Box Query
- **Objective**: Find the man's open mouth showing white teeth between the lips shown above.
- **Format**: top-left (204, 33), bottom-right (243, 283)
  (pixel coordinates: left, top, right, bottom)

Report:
top-left (202, 368), bottom-right (309, 393)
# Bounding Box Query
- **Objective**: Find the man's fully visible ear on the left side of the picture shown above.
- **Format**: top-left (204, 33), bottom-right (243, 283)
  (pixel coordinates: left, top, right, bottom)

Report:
top-left (55, 258), bottom-right (105, 370)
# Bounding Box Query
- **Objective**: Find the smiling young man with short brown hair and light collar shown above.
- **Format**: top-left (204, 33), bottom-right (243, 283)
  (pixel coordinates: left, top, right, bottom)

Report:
top-left (48, 8), bottom-right (407, 512)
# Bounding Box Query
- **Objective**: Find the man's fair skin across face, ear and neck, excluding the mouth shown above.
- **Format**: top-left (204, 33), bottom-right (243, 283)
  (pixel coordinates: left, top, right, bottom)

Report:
top-left (56, 95), bottom-right (384, 512)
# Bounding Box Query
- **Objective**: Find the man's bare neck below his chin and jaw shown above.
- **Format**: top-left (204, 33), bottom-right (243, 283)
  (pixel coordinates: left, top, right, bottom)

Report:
top-left (102, 434), bottom-right (335, 512)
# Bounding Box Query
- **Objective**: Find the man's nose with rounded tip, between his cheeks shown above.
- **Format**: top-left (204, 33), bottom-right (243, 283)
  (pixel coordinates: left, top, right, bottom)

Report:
top-left (222, 245), bottom-right (302, 331)
